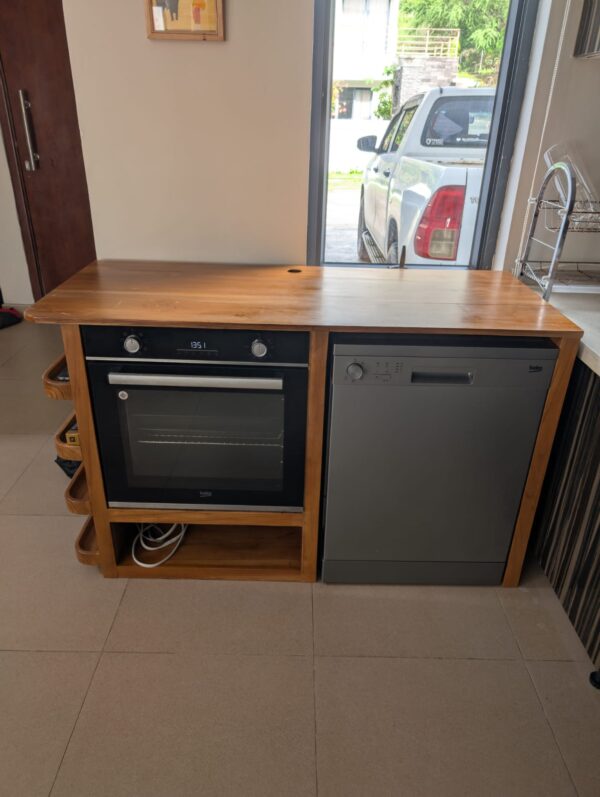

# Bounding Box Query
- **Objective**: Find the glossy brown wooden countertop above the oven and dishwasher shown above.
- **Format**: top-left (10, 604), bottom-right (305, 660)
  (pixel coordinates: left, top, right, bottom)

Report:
top-left (25, 260), bottom-right (581, 337)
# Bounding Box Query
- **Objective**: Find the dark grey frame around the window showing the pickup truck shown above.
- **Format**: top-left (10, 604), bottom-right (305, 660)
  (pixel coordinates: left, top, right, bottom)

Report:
top-left (306, 0), bottom-right (539, 269)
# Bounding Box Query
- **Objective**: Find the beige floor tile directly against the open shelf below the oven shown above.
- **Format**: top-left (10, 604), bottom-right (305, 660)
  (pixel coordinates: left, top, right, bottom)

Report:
top-left (107, 580), bottom-right (312, 655)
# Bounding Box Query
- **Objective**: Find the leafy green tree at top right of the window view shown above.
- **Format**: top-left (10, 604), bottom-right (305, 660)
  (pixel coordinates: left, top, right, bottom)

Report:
top-left (400, 0), bottom-right (510, 71)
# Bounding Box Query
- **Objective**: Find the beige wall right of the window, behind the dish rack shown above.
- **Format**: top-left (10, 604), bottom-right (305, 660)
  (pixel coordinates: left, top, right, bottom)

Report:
top-left (494, 0), bottom-right (600, 270)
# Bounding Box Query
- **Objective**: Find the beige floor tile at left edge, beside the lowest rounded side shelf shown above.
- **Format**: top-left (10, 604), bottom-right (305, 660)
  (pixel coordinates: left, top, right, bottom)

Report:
top-left (0, 516), bottom-right (126, 651)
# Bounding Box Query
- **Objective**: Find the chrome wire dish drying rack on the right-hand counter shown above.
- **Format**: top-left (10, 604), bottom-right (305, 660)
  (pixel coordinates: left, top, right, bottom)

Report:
top-left (515, 161), bottom-right (600, 301)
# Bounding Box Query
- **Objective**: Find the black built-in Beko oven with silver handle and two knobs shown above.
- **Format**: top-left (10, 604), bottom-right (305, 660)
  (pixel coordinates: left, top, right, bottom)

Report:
top-left (82, 327), bottom-right (309, 511)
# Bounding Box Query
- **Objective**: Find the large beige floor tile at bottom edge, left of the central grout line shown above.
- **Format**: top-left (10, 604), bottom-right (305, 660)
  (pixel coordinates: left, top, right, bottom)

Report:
top-left (52, 653), bottom-right (315, 797)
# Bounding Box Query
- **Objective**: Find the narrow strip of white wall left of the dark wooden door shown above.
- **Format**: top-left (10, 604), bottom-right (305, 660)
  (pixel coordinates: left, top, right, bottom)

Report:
top-left (0, 145), bottom-right (33, 304)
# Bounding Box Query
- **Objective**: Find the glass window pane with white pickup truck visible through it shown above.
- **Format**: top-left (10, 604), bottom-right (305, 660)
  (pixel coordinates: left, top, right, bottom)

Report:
top-left (324, 0), bottom-right (510, 268)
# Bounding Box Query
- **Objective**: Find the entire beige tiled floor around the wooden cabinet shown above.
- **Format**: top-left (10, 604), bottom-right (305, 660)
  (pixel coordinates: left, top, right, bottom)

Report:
top-left (0, 325), bottom-right (600, 797)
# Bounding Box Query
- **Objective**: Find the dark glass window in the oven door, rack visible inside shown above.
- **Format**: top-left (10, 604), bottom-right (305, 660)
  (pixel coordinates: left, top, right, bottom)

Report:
top-left (120, 389), bottom-right (284, 490)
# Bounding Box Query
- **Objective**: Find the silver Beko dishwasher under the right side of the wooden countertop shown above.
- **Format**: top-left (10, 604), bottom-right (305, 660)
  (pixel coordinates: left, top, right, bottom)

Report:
top-left (322, 338), bottom-right (557, 584)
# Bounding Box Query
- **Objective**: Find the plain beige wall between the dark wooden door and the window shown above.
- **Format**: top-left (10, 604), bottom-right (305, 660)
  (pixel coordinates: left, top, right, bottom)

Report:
top-left (64, 0), bottom-right (313, 263)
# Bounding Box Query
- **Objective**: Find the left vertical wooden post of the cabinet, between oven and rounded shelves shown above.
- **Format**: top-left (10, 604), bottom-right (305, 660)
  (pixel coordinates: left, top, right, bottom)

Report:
top-left (62, 324), bottom-right (117, 578)
